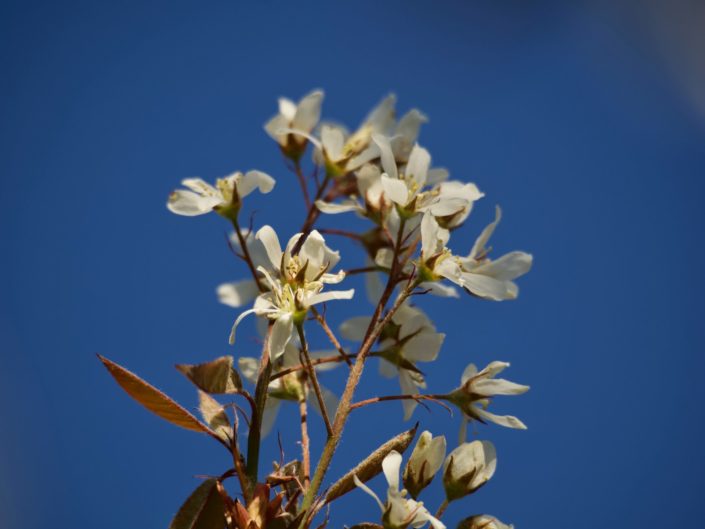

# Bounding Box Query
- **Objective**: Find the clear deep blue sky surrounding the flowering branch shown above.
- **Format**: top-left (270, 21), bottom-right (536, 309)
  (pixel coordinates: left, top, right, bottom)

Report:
top-left (0, 1), bottom-right (705, 529)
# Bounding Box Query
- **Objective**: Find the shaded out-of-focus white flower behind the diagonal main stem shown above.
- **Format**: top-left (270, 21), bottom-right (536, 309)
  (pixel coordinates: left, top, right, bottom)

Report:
top-left (340, 303), bottom-right (445, 420)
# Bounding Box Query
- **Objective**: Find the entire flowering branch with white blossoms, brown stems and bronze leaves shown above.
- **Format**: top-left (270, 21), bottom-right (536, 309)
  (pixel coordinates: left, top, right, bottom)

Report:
top-left (101, 86), bottom-right (532, 529)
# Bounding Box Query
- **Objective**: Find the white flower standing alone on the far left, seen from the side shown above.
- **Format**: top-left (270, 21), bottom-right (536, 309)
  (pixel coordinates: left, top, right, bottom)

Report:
top-left (167, 170), bottom-right (275, 217)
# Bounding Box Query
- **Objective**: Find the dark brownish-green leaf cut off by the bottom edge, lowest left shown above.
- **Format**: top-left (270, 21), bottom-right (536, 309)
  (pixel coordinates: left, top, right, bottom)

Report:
top-left (169, 479), bottom-right (225, 529)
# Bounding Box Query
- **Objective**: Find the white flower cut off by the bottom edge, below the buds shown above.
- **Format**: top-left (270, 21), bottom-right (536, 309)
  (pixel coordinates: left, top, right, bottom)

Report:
top-left (353, 450), bottom-right (445, 529)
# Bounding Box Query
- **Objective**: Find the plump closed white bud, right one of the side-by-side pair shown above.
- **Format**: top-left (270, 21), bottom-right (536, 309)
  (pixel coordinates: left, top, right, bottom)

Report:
top-left (443, 441), bottom-right (497, 501)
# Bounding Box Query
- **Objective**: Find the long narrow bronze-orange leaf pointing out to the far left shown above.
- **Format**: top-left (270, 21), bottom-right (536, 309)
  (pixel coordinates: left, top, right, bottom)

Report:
top-left (98, 355), bottom-right (217, 437)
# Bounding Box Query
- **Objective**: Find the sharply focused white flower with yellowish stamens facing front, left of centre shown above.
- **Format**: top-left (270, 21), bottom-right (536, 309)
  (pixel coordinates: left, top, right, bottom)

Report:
top-left (230, 226), bottom-right (355, 358)
